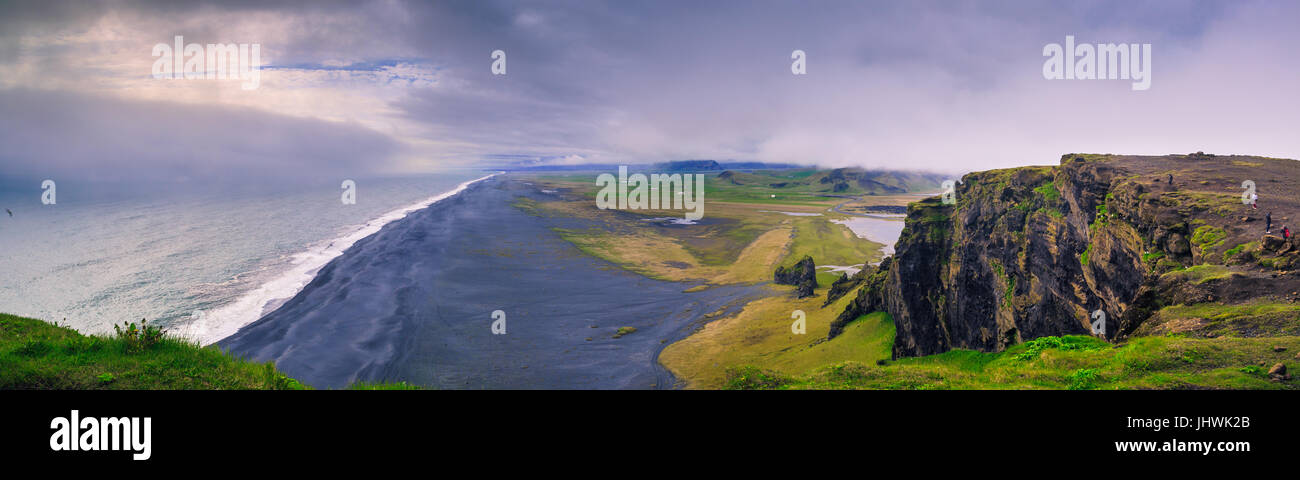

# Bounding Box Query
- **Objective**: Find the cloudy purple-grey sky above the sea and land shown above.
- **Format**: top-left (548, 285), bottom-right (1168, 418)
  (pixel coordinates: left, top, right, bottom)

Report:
top-left (0, 0), bottom-right (1300, 182)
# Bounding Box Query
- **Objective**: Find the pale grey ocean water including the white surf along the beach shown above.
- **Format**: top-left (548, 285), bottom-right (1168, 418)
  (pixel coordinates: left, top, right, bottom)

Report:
top-left (0, 170), bottom-right (490, 345)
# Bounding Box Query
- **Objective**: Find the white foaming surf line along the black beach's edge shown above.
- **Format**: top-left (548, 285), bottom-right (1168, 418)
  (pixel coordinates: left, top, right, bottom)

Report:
top-left (178, 172), bottom-right (504, 345)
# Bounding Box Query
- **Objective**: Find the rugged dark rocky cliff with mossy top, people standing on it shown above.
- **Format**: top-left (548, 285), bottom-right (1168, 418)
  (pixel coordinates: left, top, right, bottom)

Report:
top-left (832, 155), bottom-right (1300, 356)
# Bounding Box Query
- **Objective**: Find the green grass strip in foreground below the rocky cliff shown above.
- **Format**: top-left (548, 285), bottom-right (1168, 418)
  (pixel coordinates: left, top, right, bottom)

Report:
top-left (725, 313), bottom-right (1300, 390)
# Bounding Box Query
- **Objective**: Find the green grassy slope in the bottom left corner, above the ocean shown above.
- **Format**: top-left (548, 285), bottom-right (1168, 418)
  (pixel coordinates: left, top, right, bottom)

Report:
top-left (0, 313), bottom-right (416, 390)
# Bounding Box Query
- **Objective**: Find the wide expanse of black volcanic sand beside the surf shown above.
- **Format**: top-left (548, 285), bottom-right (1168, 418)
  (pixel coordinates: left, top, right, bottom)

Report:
top-left (218, 177), bottom-right (763, 389)
